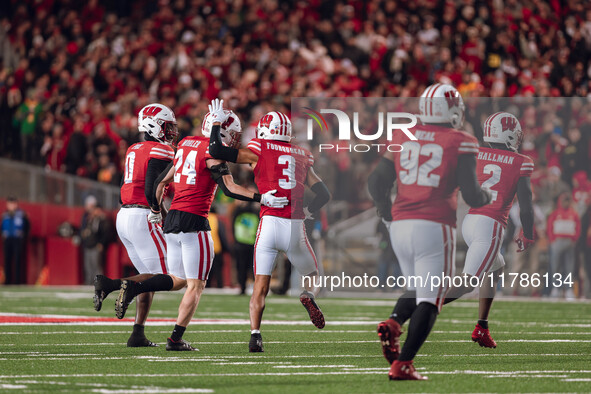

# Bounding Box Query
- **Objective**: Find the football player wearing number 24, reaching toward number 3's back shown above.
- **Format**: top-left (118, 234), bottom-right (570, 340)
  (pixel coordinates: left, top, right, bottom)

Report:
top-left (116, 104), bottom-right (288, 351)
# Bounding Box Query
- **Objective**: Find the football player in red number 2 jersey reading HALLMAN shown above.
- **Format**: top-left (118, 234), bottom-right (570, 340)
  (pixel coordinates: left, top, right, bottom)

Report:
top-left (445, 112), bottom-right (534, 348)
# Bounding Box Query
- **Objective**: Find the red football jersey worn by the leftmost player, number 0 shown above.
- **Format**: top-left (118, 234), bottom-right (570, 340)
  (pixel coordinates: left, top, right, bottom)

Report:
top-left (121, 141), bottom-right (174, 206)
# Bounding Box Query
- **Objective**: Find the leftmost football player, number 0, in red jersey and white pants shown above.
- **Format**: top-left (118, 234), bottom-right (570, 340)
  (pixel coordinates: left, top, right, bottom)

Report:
top-left (93, 104), bottom-right (178, 347)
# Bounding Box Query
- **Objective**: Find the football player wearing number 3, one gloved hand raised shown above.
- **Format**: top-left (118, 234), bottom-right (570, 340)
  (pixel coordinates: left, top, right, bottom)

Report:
top-left (209, 103), bottom-right (330, 352)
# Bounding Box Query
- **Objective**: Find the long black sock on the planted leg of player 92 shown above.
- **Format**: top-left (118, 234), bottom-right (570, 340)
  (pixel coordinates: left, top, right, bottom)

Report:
top-left (398, 302), bottom-right (438, 361)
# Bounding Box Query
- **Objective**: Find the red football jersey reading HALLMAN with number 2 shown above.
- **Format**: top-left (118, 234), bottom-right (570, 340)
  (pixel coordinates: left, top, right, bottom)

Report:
top-left (469, 148), bottom-right (534, 226)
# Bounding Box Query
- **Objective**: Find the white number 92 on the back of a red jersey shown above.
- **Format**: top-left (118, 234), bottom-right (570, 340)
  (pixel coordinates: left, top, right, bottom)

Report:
top-left (398, 141), bottom-right (443, 187)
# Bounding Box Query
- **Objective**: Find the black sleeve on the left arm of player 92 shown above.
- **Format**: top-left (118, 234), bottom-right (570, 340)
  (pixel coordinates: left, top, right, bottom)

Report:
top-left (367, 158), bottom-right (396, 221)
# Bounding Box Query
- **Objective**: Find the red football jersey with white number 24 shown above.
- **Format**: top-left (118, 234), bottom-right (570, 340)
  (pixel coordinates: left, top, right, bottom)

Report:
top-left (170, 137), bottom-right (217, 218)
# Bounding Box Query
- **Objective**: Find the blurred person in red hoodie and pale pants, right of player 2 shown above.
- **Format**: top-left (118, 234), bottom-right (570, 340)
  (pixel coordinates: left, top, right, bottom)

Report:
top-left (547, 193), bottom-right (581, 299)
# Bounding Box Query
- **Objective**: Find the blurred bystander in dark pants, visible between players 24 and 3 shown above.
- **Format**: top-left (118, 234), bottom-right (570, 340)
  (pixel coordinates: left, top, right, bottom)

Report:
top-left (232, 201), bottom-right (259, 294)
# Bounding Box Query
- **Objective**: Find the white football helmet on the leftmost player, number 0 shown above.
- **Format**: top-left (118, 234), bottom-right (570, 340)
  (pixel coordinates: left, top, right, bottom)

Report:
top-left (137, 103), bottom-right (179, 144)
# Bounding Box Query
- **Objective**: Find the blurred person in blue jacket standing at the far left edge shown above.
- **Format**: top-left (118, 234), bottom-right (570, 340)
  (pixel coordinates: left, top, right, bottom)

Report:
top-left (2, 197), bottom-right (29, 285)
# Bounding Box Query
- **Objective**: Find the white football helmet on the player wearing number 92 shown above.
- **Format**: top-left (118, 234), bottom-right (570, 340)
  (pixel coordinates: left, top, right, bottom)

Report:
top-left (419, 83), bottom-right (466, 129)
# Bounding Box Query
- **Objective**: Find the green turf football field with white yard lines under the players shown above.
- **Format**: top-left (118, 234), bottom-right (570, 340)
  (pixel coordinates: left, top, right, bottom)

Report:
top-left (0, 287), bottom-right (591, 393)
